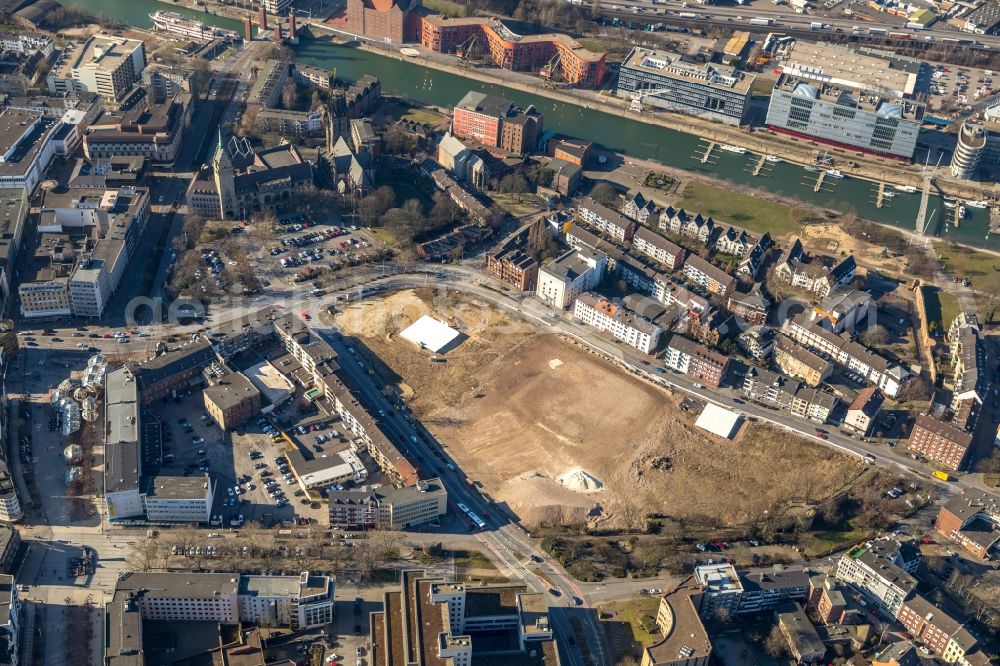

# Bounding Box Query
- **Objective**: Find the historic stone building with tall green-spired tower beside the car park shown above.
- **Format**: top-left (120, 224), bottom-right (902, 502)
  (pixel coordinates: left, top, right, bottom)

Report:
top-left (187, 130), bottom-right (314, 220)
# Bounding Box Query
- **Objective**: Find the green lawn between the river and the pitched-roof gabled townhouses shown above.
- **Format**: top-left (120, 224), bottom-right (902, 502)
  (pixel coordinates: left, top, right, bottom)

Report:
top-left (677, 182), bottom-right (800, 237)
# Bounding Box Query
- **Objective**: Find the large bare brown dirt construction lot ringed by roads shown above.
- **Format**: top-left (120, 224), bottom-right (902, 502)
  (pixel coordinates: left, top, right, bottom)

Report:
top-left (336, 291), bottom-right (861, 525)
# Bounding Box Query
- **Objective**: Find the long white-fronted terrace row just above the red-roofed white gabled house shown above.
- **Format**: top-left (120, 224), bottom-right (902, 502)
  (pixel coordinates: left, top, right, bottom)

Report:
top-left (781, 313), bottom-right (910, 398)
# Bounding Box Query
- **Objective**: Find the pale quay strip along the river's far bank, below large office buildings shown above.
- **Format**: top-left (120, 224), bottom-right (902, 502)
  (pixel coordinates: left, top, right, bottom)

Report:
top-left (308, 21), bottom-right (996, 199)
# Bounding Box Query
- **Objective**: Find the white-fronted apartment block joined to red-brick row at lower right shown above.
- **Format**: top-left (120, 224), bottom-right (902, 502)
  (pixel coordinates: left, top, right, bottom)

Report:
top-left (837, 537), bottom-right (920, 618)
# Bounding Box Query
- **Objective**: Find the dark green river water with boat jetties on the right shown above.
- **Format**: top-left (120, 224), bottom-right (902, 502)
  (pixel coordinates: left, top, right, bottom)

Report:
top-left (70, 0), bottom-right (1000, 250)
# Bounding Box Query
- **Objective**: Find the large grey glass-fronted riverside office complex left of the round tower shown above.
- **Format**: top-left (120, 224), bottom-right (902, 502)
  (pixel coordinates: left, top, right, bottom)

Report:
top-left (767, 41), bottom-right (924, 161)
